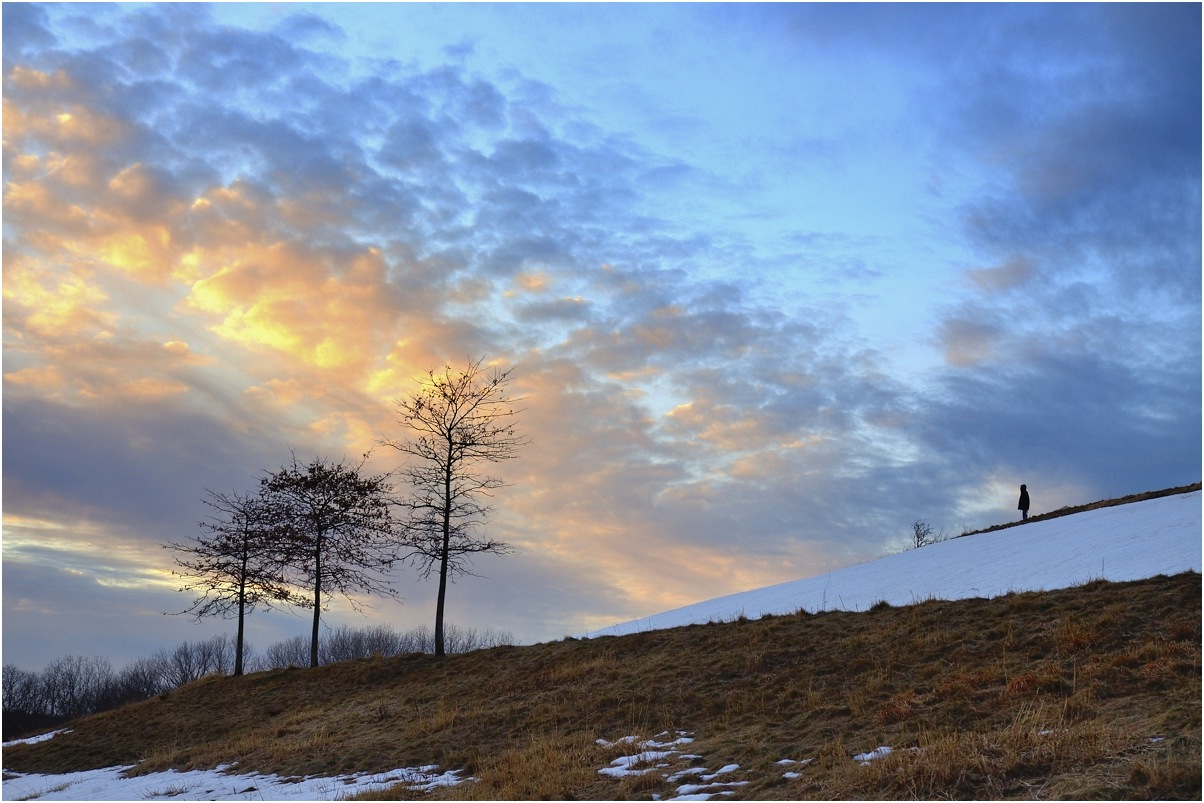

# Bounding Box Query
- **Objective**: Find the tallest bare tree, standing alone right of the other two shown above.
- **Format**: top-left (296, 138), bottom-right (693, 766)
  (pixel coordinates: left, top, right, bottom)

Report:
top-left (383, 359), bottom-right (527, 655)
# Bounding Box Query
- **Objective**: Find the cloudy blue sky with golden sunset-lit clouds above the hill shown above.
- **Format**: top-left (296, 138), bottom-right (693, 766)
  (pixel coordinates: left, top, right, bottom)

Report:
top-left (4, 4), bottom-right (1202, 669)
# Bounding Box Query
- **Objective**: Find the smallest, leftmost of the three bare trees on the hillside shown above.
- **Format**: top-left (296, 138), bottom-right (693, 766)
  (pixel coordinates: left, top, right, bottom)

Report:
top-left (164, 490), bottom-right (299, 685)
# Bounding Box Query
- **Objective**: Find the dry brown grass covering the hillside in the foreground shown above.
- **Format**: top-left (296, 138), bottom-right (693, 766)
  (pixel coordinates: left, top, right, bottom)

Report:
top-left (4, 573), bottom-right (1200, 799)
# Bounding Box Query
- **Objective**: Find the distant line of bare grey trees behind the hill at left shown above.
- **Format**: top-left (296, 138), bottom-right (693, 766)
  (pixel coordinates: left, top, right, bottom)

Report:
top-left (2, 624), bottom-right (514, 740)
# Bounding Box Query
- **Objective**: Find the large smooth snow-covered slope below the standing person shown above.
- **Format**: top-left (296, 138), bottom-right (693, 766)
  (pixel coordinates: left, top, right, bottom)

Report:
top-left (588, 491), bottom-right (1200, 637)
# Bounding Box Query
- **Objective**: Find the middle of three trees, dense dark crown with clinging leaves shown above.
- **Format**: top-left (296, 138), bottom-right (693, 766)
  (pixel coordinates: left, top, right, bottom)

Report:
top-left (261, 455), bottom-right (396, 667)
